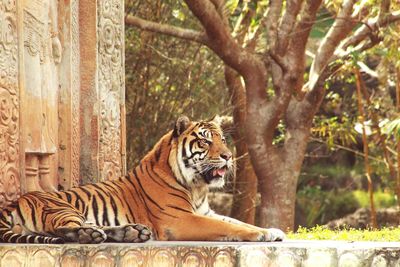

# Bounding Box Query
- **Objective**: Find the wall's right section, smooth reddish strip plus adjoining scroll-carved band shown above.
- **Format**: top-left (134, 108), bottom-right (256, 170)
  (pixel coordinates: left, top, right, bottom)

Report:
top-left (80, 0), bottom-right (126, 182)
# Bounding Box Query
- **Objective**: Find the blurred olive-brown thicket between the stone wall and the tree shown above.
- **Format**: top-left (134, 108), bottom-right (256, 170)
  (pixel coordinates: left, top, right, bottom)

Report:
top-left (125, 1), bottom-right (232, 168)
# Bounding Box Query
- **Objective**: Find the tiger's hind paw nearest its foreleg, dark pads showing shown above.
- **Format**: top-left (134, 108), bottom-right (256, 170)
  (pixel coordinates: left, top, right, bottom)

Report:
top-left (101, 224), bottom-right (151, 243)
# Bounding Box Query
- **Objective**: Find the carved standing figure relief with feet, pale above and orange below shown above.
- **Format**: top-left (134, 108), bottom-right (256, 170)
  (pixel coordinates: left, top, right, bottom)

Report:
top-left (23, 0), bottom-right (62, 191)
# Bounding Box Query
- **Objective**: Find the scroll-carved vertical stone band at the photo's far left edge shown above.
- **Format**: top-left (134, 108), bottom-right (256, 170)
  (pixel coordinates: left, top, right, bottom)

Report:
top-left (0, 0), bottom-right (20, 207)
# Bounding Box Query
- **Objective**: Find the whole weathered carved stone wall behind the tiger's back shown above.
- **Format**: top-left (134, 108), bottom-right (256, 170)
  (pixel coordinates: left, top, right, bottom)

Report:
top-left (0, 0), bottom-right (126, 206)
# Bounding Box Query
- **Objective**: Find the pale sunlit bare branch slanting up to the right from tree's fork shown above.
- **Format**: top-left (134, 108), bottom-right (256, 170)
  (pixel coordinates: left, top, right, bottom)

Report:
top-left (303, 0), bottom-right (356, 93)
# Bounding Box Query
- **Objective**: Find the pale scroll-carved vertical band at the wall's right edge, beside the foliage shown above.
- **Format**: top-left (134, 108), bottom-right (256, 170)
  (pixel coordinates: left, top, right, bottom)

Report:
top-left (97, 0), bottom-right (125, 179)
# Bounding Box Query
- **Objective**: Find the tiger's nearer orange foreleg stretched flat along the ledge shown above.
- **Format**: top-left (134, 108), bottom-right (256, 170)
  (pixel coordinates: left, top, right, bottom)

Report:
top-left (157, 213), bottom-right (272, 242)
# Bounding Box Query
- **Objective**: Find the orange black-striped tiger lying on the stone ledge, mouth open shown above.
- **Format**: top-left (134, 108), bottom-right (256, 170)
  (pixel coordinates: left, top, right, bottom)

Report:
top-left (0, 116), bottom-right (285, 244)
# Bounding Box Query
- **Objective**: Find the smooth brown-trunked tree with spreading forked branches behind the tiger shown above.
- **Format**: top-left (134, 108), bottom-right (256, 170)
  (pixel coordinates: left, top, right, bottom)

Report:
top-left (126, 0), bottom-right (400, 229)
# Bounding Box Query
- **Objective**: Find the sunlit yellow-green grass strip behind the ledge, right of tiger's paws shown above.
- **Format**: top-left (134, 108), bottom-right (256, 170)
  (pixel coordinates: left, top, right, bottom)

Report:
top-left (288, 226), bottom-right (400, 242)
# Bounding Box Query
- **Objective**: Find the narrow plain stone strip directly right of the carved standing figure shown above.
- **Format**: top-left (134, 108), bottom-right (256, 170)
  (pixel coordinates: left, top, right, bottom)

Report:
top-left (58, 0), bottom-right (82, 192)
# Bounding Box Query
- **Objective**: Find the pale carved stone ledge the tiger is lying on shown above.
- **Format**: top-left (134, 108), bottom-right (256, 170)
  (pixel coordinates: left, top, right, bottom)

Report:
top-left (0, 240), bottom-right (400, 267)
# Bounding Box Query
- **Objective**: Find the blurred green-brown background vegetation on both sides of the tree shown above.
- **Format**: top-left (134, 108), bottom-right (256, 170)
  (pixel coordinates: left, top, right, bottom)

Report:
top-left (125, 0), bottom-right (400, 230)
